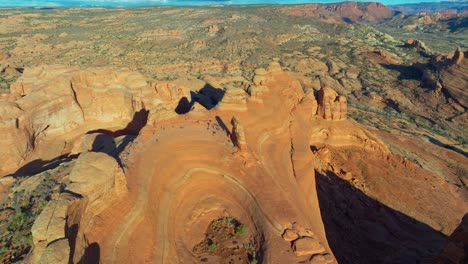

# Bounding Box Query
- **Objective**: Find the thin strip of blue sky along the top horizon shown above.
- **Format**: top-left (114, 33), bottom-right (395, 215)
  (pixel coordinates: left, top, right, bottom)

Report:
top-left (0, 0), bottom-right (462, 7)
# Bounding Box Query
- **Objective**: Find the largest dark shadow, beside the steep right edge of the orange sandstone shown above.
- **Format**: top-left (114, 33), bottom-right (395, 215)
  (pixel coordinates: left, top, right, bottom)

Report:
top-left (316, 172), bottom-right (446, 264)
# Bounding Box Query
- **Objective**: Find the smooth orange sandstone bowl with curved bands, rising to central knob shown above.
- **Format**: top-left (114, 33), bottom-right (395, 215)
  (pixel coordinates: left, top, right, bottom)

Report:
top-left (58, 62), bottom-right (334, 263)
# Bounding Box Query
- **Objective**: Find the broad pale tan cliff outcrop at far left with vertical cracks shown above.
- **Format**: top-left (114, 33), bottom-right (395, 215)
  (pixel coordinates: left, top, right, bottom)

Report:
top-left (0, 66), bottom-right (155, 174)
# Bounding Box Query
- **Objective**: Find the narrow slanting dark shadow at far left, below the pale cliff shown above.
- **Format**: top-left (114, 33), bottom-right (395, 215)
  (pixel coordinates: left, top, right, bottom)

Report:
top-left (12, 154), bottom-right (78, 177)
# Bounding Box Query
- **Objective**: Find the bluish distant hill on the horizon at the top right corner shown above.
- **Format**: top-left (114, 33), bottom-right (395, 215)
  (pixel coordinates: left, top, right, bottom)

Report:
top-left (389, 1), bottom-right (468, 14)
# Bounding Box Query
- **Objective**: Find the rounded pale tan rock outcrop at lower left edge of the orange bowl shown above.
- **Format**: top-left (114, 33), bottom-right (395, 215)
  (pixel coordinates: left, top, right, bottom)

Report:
top-left (26, 152), bottom-right (127, 264)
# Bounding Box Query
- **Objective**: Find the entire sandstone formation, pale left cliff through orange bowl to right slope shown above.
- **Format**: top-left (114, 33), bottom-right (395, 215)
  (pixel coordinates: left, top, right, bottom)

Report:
top-left (0, 64), bottom-right (466, 263)
